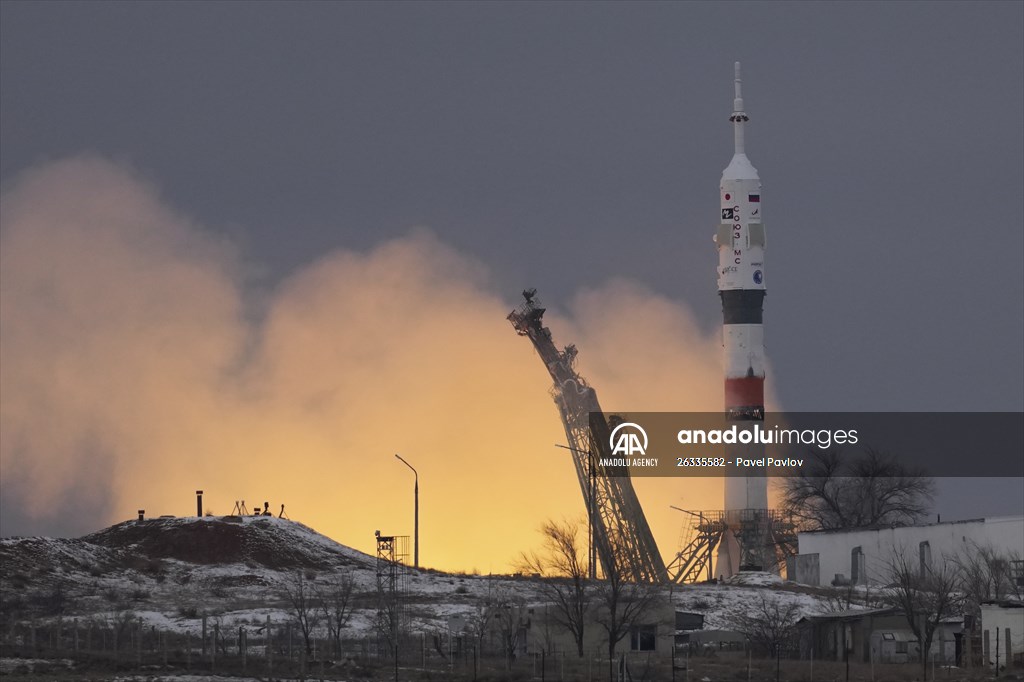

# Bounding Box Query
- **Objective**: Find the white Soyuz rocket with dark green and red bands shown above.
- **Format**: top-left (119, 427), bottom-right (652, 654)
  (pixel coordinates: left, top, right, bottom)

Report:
top-left (715, 61), bottom-right (768, 515)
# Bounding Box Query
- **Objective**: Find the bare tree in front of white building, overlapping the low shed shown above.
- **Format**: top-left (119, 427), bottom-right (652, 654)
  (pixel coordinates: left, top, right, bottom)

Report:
top-left (887, 551), bottom-right (963, 679)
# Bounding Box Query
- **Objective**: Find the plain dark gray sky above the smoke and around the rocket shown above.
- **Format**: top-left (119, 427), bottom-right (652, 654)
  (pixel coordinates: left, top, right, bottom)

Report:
top-left (0, 0), bottom-right (1024, 536)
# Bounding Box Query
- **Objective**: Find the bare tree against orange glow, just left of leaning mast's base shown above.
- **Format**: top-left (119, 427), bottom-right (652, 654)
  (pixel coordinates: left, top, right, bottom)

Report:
top-left (519, 520), bottom-right (594, 658)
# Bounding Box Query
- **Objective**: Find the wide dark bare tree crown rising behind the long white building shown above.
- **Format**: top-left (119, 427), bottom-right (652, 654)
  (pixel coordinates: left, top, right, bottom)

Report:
top-left (782, 447), bottom-right (935, 530)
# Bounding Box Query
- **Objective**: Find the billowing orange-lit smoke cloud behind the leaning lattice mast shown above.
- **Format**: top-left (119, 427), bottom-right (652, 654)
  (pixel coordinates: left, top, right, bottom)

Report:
top-left (0, 158), bottom-right (753, 571)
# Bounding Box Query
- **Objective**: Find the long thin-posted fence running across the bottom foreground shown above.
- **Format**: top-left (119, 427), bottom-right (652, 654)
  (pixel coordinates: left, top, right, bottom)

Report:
top-left (9, 616), bottom-right (991, 682)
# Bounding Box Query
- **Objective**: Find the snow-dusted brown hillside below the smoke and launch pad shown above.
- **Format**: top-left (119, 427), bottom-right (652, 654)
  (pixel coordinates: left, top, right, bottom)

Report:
top-left (0, 516), bottom-right (843, 635)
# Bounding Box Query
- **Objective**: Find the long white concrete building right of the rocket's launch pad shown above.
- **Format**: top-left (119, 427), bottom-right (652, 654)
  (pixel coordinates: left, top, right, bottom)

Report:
top-left (786, 516), bottom-right (1024, 585)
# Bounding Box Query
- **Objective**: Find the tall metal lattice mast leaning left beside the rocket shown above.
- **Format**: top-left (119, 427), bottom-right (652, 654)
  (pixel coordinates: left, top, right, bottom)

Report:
top-left (508, 289), bottom-right (668, 583)
